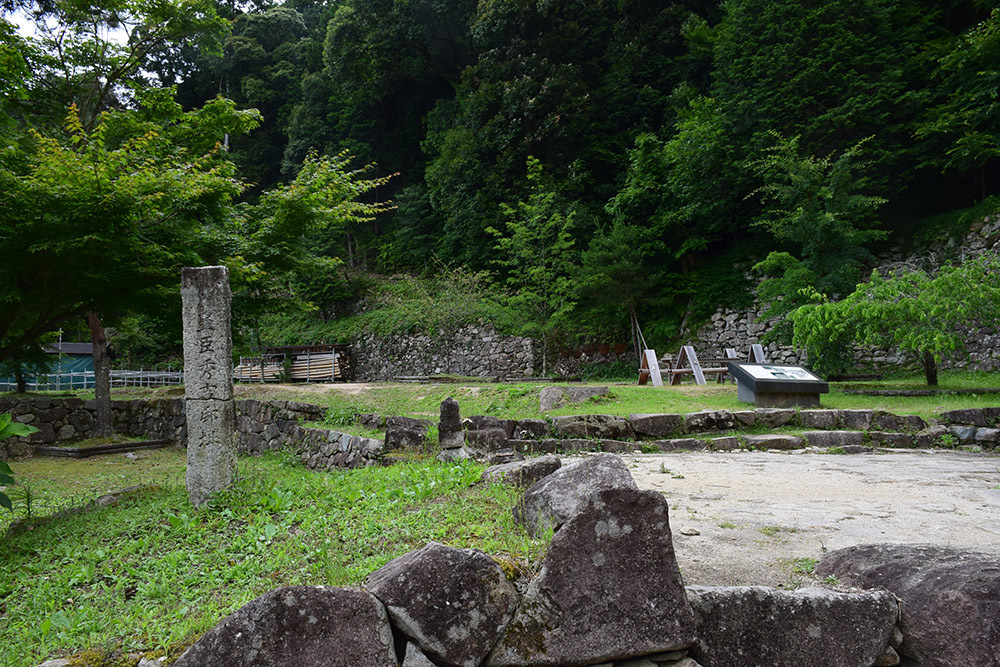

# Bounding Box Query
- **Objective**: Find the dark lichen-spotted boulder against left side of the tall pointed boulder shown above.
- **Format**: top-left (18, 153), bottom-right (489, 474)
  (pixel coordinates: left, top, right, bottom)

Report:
top-left (365, 542), bottom-right (518, 667)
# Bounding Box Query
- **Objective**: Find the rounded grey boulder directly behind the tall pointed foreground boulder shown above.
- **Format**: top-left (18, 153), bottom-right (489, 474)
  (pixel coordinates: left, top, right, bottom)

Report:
top-left (514, 454), bottom-right (638, 536)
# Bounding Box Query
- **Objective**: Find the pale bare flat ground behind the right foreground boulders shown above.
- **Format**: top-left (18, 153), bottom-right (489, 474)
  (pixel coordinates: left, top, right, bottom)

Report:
top-left (623, 450), bottom-right (1000, 586)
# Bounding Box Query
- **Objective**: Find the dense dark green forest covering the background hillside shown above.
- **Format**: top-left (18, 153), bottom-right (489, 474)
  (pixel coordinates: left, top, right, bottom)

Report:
top-left (2, 0), bottom-right (1000, 368)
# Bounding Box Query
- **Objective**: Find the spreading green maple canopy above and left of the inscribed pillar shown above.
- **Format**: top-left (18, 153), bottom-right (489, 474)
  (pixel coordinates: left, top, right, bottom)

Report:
top-left (0, 95), bottom-right (256, 366)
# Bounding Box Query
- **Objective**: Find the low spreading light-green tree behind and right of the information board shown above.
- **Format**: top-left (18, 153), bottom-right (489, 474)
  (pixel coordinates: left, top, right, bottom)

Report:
top-left (789, 255), bottom-right (1000, 385)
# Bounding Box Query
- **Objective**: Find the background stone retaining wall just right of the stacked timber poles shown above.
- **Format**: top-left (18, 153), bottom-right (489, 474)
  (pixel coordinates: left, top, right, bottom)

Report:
top-left (351, 324), bottom-right (536, 382)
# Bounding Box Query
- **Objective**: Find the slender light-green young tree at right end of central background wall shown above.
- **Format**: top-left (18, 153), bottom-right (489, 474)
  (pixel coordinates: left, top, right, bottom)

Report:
top-left (486, 157), bottom-right (575, 375)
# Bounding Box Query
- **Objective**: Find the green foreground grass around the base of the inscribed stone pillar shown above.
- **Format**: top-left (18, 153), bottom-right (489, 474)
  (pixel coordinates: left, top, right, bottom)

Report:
top-left (0, 449), bottom-right (545, 667)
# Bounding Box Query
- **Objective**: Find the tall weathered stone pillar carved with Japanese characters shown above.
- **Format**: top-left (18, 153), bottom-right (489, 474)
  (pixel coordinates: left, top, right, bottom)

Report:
top-left (181, 266), bottom-right (236, 505)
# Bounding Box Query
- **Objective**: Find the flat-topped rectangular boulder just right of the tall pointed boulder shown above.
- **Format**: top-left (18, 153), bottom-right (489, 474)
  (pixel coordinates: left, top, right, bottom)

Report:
top-left (687, 586), bottom-right (899, 667)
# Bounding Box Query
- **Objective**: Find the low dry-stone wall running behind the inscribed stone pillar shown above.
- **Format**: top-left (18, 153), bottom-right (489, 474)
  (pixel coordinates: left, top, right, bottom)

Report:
top-left (0, 397), bottom-right (383, 470)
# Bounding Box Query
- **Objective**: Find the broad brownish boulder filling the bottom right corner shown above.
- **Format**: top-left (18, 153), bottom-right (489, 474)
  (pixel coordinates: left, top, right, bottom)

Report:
top-left (816, 544), bottom-right (1000, 667)
